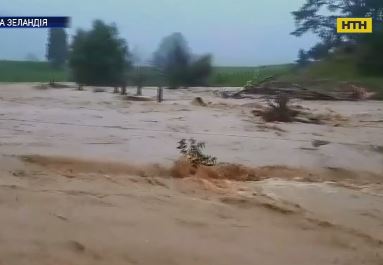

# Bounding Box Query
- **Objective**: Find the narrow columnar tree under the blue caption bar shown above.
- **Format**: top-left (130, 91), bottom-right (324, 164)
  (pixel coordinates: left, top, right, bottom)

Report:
top-left (47, 28), bottom-right (68, 68)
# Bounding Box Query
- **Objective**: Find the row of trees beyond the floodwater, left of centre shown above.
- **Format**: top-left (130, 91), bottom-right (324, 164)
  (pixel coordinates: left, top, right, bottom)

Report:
top-left (47, 20), bottom-right (212, 88)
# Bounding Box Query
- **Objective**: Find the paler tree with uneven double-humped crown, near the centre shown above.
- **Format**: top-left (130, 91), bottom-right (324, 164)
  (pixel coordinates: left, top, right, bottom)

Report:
top-left (152, 33), bottom-right (212, 88)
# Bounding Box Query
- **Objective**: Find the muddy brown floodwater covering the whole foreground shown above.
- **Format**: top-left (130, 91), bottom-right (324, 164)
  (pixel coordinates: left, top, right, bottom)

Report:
top-left (0, 84), bottom-right (383, 265)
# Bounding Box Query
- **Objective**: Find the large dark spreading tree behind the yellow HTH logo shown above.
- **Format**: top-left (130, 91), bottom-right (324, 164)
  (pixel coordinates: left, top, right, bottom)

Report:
top-left (292, 0), bottom-right (383, 75)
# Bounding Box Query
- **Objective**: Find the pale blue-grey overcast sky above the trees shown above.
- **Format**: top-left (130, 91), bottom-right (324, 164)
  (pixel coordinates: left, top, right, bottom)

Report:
top-left (0, 0), bottom-right (316, 66)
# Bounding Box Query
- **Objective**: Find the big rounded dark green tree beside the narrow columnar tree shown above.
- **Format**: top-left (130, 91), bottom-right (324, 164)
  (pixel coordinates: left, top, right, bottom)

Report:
top-left (69, 20), bottom-right (130, 86)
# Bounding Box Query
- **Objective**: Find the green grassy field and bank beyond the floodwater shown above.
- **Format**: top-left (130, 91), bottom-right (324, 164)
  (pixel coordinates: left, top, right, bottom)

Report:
top-left (0, 59), bottom-right (383, 99)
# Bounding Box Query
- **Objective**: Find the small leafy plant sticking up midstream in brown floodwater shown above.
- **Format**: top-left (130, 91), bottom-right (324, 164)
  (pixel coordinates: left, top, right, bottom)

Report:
top-left (177, 138), bottom-right (217, 168)
